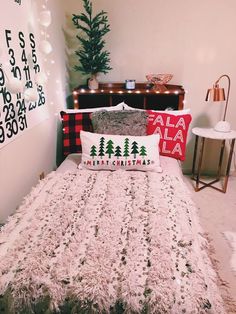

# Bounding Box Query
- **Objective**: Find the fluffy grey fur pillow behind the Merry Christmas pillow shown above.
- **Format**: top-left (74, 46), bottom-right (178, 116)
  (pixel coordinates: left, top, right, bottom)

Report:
top-left (91, 110), bottom-right (148, 136)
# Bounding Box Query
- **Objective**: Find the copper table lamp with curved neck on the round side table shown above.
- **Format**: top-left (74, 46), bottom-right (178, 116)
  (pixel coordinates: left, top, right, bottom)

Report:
top-left (206, 74), bottom-right (231, 132)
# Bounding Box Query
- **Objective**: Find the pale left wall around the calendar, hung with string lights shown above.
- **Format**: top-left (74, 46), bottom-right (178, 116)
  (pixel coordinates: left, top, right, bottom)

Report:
top-left (0, 0), bottom-right (66, 223)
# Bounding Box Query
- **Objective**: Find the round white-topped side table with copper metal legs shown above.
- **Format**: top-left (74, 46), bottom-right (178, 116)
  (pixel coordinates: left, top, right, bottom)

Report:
top-left (192, 128), bottom-right (236, 193)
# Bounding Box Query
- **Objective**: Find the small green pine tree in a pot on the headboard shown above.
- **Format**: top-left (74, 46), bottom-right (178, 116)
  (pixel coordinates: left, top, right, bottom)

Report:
top-left (72, 0), bottom-right (112, 89)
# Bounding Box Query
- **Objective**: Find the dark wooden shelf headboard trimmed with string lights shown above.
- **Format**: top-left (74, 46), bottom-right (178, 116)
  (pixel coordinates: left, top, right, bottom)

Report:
top-left (73, 83), bottom-right (185, 110)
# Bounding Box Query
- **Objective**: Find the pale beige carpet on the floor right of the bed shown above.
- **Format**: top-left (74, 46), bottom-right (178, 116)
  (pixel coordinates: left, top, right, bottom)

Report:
top-left (185, 174), bottom-right (236, 314)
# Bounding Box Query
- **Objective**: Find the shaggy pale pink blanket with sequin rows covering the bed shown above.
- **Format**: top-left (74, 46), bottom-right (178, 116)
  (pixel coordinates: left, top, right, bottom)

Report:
top-left (0, 84), bottom-right (225, 314)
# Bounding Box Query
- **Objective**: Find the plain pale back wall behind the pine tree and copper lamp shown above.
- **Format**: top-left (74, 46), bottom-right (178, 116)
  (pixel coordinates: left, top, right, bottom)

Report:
top-left (62, 0), bottom-right (236, 172)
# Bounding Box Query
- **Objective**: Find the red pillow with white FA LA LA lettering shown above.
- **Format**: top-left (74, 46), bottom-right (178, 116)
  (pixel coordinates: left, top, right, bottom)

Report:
top-left (147, 110), bottom-right (192, 160)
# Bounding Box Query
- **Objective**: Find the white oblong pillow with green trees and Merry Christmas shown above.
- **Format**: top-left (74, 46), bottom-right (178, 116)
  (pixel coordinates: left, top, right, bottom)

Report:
top-left (80, 131), bottom-right (162, 172)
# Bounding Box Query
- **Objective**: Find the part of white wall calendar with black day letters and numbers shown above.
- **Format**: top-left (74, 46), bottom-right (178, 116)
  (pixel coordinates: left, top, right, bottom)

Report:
top-left (0, 29), bottom-right (48, 149)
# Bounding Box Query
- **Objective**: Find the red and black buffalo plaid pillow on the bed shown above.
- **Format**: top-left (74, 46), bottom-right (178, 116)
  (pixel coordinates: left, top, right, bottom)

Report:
top-left (60, 111), bottom-right (93, 156)
